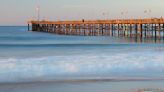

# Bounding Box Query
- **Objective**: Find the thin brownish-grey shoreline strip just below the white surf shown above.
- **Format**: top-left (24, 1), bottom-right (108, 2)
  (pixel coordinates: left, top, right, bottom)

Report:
top-left (0, 77), bottom-right (164, 85)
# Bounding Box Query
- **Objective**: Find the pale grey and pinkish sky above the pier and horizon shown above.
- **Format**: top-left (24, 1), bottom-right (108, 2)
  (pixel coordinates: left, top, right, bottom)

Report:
top-left (0, 0), bottom-right (164, 26)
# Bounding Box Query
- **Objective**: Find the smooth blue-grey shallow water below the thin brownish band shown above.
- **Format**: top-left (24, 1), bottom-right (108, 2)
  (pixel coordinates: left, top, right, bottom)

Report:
top-left (0, 81), bottom-right (164, 92)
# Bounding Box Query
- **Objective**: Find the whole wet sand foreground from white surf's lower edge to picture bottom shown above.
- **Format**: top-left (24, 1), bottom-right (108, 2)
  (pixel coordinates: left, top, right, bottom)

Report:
top-left (0, 78), bottom-right (164, 92)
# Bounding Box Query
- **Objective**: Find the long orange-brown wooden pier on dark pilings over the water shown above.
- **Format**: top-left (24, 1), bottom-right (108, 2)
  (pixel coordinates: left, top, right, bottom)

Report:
top-left (28, 18), bottom-right (164, 39)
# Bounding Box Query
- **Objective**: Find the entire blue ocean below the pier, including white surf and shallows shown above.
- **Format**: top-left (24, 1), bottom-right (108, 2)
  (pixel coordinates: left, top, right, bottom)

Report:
top-left (0, 26), bottom-right (164, 92)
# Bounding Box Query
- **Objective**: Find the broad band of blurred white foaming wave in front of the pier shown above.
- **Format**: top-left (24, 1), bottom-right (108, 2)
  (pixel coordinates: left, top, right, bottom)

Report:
top-left (0, 52), bottom-right (164, 82)
